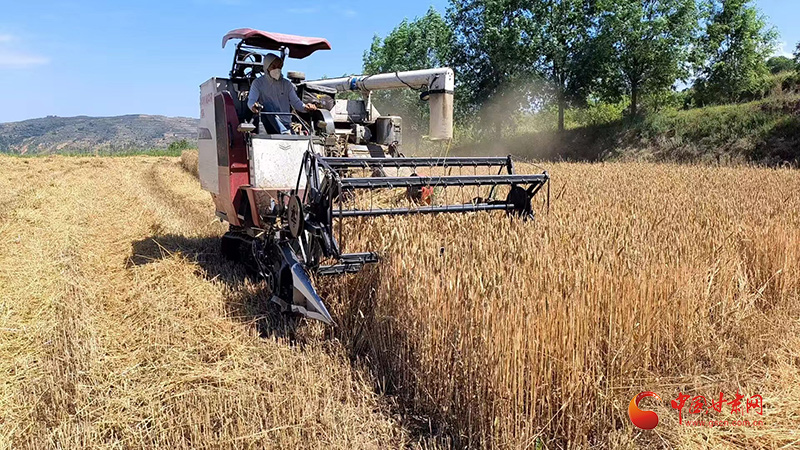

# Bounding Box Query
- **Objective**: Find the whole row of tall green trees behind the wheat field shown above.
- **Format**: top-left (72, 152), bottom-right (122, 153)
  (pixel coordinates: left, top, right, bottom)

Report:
top-left (364, 0), bottom-right (800, 135)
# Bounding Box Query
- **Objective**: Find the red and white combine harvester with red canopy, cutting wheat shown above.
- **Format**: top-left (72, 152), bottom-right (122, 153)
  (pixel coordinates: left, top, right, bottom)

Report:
top-left (199, 28), bottom-right (549, 324)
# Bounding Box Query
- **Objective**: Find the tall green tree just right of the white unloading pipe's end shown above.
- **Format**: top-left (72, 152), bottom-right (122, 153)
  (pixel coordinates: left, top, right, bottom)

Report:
top-left (448, 0), bottom-right (539, 135)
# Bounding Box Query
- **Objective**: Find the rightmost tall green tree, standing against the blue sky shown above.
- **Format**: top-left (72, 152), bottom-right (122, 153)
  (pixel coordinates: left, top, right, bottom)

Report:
top-left (695, 0), bottom-right (778, 103)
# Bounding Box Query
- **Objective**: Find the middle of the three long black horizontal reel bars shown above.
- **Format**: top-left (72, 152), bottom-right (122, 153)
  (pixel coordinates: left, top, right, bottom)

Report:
top-left (339, 174), bottom-right (549, 189)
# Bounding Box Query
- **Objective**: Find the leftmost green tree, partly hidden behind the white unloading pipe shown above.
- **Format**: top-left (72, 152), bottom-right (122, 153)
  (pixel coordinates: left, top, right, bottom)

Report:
top-left (364, 7), bottom-right (453, 136)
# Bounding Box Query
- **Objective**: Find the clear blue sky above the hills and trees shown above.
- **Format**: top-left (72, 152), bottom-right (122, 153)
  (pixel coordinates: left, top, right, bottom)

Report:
top-left (0, 0), bottom-right (800, 122)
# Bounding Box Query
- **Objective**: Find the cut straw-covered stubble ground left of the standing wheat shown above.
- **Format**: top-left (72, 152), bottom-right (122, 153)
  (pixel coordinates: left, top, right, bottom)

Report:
top-left (0, 157), bottom-right (407, 449)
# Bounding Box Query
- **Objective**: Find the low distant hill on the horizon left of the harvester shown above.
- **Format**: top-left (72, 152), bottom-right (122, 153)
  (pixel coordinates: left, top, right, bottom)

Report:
top-left (0, 114), bottom-right (197, 154)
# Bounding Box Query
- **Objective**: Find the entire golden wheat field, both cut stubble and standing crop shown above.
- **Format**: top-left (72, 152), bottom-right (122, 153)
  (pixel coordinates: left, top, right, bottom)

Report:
top-left (0, 156), bottom-right (800, 449)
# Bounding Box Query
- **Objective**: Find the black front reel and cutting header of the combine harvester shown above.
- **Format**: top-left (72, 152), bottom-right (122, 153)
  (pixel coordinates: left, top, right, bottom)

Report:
top-left (225, 155), bottom-right (549, 325)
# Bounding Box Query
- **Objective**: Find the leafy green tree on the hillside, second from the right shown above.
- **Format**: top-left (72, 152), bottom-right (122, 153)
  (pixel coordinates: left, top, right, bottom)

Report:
top-left (600, 0), bottom-right (698, 116)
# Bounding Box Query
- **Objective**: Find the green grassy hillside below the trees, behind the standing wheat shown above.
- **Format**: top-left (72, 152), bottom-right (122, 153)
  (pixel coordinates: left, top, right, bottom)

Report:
top-left (454, 94), bottom-right (800, 167)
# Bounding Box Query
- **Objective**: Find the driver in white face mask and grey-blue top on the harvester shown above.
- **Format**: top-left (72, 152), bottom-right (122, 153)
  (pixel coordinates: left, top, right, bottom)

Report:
top-left (247, 53), bottom-right (317, 134)
